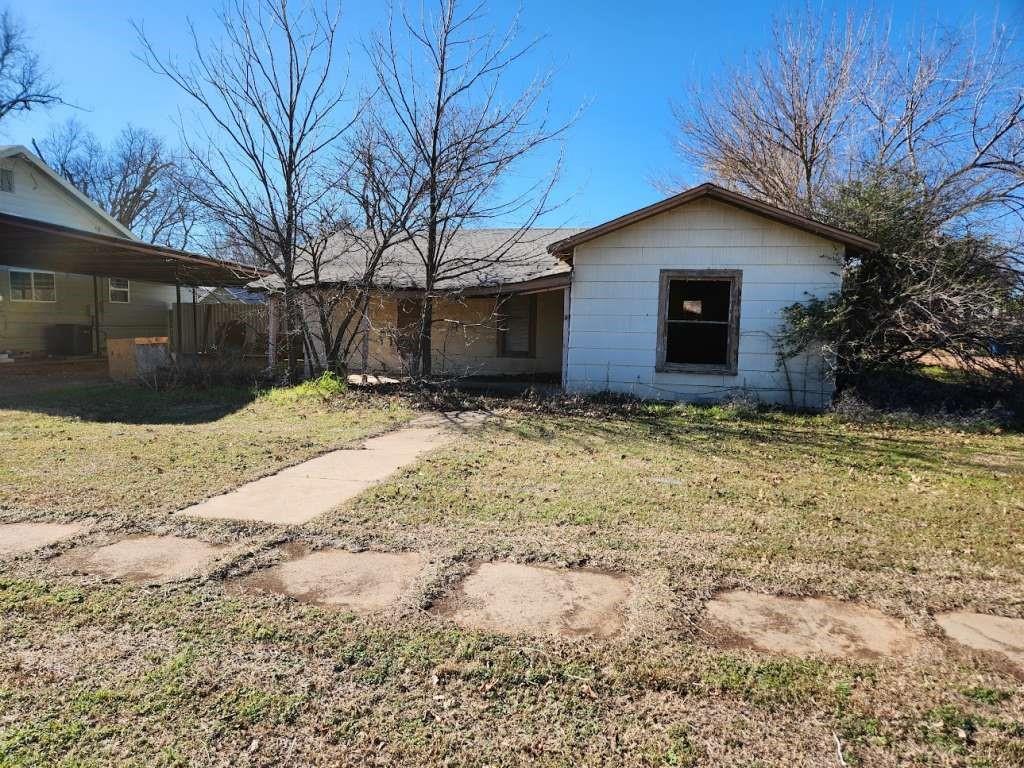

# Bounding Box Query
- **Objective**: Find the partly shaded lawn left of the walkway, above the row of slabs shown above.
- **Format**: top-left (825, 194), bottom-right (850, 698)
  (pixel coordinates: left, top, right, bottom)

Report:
top-left (0, 380), bottom-right (411, 516)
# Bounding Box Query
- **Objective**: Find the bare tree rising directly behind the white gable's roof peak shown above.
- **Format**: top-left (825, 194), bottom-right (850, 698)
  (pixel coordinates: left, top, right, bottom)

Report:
top-left (669, 13), bottom-right (868, 213)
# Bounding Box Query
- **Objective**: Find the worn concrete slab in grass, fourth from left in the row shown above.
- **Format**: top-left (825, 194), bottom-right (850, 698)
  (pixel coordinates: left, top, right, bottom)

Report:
top-left (435, 562), bottom-right (632, 638)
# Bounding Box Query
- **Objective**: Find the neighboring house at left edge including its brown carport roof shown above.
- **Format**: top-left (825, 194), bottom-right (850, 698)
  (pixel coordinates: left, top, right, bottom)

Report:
top-left (0, 146), bottom-right (264, 356)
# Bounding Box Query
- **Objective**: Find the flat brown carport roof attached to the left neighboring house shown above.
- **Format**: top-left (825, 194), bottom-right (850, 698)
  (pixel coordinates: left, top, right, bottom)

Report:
top-left (0, 213), bottom-right (263, 286)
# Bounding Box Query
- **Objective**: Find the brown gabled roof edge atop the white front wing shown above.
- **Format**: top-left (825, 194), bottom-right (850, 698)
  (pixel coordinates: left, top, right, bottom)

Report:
top-left (548, 183), bottom-right (879, 263)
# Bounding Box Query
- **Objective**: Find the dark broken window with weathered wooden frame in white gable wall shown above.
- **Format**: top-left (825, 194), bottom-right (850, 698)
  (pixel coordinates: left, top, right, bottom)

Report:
top-left (657, 269), bottom-right (742, 376)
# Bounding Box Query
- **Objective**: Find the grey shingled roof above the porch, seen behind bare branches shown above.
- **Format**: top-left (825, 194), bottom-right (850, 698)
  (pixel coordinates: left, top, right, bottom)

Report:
top-left (268, 227), bottom-right (579, 294)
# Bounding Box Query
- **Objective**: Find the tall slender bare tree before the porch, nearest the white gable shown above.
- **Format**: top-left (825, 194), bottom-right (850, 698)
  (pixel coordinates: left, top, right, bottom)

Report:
top-left (369, 0), bottom-right (569, 377)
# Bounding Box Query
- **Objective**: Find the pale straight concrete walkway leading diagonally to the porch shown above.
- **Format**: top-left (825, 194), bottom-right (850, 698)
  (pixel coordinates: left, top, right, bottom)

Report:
top-left (178, 411), bottom-right (484, 525)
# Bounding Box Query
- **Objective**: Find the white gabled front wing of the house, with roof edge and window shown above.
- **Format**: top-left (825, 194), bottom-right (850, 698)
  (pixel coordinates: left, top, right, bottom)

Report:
top-left (549, 184), bottom-right (877, 408)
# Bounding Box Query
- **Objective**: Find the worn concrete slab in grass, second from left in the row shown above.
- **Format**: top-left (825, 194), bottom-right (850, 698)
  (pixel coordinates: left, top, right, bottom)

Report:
top-left (54, 536), bottom-right (227, 584)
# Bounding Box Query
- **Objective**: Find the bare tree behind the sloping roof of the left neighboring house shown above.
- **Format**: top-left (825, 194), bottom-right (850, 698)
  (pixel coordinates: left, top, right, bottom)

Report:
top-left (32, 120), bottom-right (200, 248)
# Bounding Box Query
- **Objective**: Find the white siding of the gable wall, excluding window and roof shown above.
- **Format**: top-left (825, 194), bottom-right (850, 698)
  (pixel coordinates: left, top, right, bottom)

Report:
top-left (565, 200), bottom-right (843, 408)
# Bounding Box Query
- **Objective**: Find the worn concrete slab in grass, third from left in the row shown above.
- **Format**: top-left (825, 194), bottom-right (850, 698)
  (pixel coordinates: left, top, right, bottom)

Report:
top-left (239, 545), bottom-right (426, 612)
